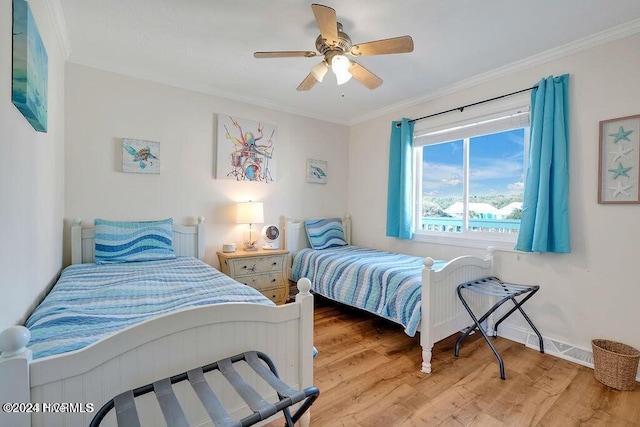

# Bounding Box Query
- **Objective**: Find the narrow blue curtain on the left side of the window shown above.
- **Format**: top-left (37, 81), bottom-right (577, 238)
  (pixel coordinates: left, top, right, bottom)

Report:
top-left (387, 118), bottom-right (414, 239)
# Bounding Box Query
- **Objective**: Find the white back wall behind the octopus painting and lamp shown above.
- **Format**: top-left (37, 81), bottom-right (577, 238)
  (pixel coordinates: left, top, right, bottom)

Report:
top-left (65, 63), bottom-right (349, 266)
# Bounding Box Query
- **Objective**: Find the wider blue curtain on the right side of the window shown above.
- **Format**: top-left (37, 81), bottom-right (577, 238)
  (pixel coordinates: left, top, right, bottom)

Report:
top-left (515, 74), bottom-right (571, 252)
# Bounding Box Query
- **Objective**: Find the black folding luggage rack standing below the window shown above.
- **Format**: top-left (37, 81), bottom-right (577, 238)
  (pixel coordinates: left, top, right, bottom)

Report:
top-left (455, 277), bottom-right (544, 380)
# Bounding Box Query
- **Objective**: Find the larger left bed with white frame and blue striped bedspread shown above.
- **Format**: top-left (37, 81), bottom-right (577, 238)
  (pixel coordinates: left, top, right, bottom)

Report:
top-left (0, 219), bottom-right (313, 427)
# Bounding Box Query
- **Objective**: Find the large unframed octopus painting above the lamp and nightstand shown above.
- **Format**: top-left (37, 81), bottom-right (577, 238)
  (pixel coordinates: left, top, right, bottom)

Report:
top-left (216, 114), bottom-right (276, 183)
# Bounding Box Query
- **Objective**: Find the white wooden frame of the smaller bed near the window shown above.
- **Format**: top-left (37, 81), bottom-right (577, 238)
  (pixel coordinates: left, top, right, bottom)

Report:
top-left (284, 215), bottom-right (494, 373)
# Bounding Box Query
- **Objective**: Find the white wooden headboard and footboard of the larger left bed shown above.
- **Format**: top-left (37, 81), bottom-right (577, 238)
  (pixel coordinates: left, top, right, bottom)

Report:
top-left (0, 217), bottom-right (313, 427)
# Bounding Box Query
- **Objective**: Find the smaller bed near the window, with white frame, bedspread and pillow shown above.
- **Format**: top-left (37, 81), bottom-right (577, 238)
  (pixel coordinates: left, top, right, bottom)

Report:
top-left (285, 216), bottom-right (493, 373)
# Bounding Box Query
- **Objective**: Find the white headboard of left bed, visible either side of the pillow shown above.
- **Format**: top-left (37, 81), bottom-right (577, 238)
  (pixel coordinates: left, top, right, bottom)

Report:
top-left (71, 216), bottom-right (204, 264)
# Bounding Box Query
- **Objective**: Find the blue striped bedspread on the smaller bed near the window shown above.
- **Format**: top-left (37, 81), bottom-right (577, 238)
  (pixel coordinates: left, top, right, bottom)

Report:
top-left (291, 246), bottom-right (445, 337)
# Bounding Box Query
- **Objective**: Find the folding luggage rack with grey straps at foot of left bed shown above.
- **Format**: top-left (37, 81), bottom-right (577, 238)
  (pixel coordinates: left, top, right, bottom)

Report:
top-left (89, 351), bottom-right (320, 427)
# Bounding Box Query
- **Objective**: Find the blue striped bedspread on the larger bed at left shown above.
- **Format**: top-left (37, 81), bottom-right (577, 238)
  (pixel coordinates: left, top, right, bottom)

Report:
top-left (25, 257), bottom-right (274, 359)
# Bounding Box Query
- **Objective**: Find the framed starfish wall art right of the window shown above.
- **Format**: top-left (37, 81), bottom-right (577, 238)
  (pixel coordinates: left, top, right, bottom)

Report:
top-left (598, 114), bottom-right (640, 204)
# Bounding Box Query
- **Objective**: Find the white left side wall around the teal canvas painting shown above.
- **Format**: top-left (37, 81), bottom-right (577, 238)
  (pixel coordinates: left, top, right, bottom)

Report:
top-left (0, 0), bottom-right (64, 330)
